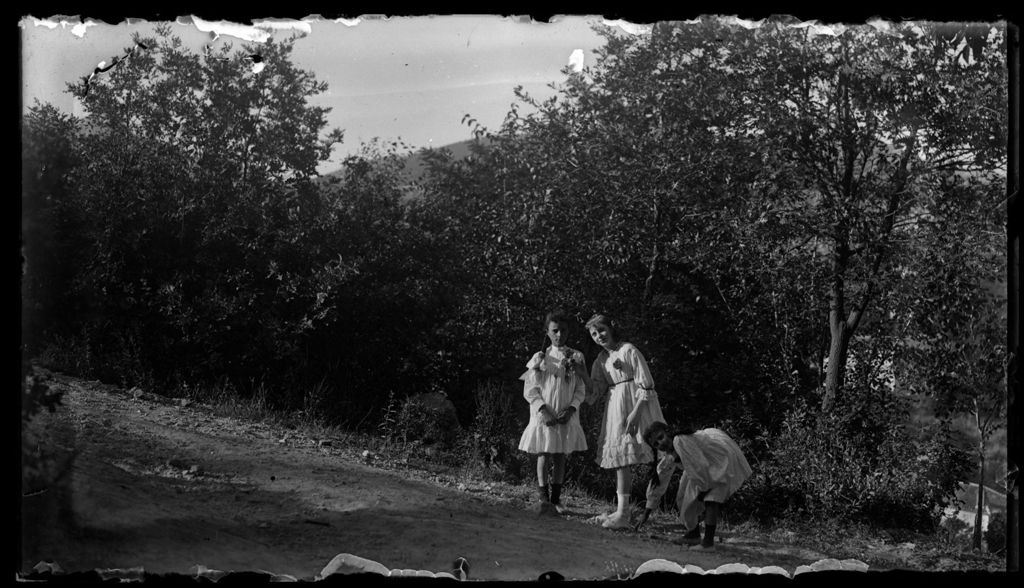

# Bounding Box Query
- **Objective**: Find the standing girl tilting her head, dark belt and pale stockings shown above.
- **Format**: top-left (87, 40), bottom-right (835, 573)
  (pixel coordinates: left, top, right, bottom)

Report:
top-left (587, 314), bottom-right (665, 529)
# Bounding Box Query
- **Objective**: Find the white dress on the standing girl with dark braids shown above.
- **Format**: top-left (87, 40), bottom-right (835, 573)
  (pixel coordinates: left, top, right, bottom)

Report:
top-left (519, 345), bottom-right (587, 454)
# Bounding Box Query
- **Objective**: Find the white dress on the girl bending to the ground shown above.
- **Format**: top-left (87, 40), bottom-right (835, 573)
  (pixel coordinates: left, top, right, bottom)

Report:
top-left (647, 428), bottom-right (751, 530)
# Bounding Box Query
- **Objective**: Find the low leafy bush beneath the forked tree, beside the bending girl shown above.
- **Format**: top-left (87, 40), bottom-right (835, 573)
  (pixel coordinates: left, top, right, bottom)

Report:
top-left (761, 374), bottom-right (970, 531)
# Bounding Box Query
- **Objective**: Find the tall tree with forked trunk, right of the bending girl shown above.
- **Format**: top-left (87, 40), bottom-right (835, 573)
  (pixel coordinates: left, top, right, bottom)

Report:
top-left (730, 24), bottom-right (1007, 412)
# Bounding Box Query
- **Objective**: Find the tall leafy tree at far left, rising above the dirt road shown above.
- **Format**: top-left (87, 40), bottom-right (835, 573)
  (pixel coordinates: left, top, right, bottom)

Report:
top-left (35, 26), bottom-right (349, 397)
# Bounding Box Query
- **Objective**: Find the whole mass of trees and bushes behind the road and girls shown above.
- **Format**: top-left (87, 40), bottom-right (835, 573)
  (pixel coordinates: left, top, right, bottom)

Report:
top-left (23, 18), bottom-right (1007, 529)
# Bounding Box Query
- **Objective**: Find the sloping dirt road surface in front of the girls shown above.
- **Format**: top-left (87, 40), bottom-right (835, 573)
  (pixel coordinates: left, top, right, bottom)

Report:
top-left (22, 375), bottom-right (828, 580)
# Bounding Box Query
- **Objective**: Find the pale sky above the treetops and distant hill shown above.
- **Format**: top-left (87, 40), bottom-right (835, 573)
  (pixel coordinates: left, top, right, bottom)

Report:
top-left (19, 14), bottom-right (622, 172)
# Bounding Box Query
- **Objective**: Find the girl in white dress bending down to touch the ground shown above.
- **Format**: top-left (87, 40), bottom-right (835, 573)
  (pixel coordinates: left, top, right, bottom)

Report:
top-left (636, 423), bottom-right (751, 549)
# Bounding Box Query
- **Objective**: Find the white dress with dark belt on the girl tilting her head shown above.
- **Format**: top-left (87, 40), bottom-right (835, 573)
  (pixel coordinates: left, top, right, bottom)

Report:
top-left (591, 343), bottom-right (665, 469)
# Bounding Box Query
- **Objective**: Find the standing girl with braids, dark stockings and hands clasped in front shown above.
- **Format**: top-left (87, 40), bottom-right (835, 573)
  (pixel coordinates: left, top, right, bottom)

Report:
top-left (519, 311), bottom-right (587, 514)
